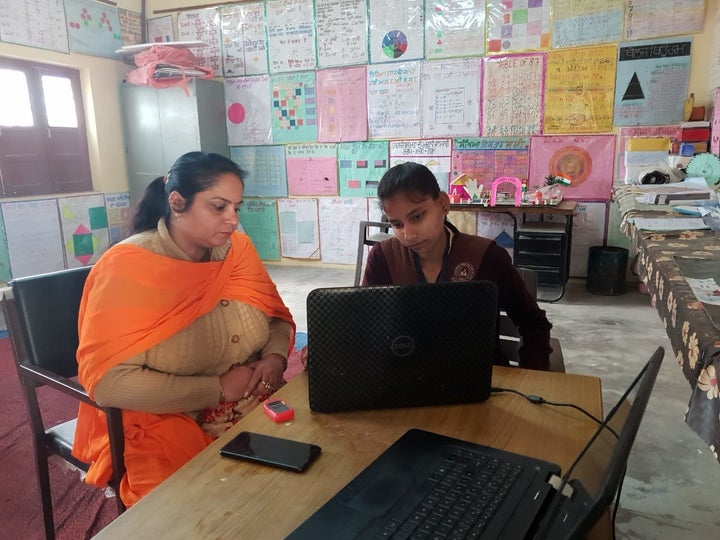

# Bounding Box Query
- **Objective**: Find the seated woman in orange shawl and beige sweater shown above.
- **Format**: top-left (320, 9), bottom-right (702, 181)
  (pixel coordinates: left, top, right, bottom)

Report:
top-left (73, 152), bottom-right (295, 506)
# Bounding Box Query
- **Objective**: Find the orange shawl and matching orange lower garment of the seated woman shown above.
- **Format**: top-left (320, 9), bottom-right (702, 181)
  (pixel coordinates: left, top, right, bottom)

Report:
top-left (73, 232), bottom-right (294, 506)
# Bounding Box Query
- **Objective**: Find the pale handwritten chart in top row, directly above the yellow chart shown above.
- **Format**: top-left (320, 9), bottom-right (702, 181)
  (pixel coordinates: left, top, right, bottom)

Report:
top-left (552, 0), bottom-right (625, 48)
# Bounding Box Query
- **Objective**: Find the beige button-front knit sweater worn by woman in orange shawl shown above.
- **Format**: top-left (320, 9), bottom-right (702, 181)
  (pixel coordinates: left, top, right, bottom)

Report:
top-left (95, 220), bottom-right (292, 416)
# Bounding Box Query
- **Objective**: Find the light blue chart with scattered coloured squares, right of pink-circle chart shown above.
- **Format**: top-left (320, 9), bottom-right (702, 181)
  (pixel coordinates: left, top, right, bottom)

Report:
top-left (270, 72), bottom-right (317, 144)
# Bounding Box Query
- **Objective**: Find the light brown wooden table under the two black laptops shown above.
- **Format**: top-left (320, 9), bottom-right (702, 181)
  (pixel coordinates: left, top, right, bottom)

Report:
top-left (95, 367), bottom-right (609, 540)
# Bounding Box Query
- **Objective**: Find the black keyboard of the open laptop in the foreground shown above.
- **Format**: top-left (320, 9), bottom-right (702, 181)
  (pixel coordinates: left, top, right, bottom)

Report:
top-left (375, 449), bottom-right (523, 540)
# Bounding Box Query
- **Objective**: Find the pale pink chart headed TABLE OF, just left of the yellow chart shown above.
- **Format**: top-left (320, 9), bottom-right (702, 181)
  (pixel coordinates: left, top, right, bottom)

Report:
top-left (481, 53), bottom-right (545, 137)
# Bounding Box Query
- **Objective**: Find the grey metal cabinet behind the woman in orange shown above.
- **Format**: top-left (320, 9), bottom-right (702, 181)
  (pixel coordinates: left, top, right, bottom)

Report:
top-left (120, 79), bottom-right (229, 207)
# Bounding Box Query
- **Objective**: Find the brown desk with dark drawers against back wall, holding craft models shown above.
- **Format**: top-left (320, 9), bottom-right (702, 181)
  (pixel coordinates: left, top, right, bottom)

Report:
top-left (450, 201), bottom-right (577, 302)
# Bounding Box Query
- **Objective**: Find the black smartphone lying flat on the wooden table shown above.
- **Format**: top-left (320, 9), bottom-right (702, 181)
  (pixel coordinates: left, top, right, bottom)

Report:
top-left (220, 431), bottom-right (320, 472)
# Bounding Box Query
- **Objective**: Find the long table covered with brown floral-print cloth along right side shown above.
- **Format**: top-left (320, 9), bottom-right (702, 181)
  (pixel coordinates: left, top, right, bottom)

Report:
top-left (613, 186), bottom-right (720, 460)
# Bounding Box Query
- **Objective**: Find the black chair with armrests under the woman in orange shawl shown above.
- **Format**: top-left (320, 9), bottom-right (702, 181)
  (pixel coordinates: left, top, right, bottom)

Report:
top-left (1, 267), bottom-right (125, 539)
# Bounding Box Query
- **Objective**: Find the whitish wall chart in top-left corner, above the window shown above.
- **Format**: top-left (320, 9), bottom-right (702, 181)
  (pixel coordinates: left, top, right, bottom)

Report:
top-left (0, 0), bottom-right (70, 53)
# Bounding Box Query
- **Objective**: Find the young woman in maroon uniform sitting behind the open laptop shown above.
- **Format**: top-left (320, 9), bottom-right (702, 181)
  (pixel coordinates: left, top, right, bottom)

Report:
top-left (362, 162), bottom-right (552, 370)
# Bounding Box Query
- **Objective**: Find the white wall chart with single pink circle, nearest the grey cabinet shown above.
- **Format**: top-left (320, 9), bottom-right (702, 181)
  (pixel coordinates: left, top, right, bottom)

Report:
top-left (225, 75), bottom-right (273, 146)
